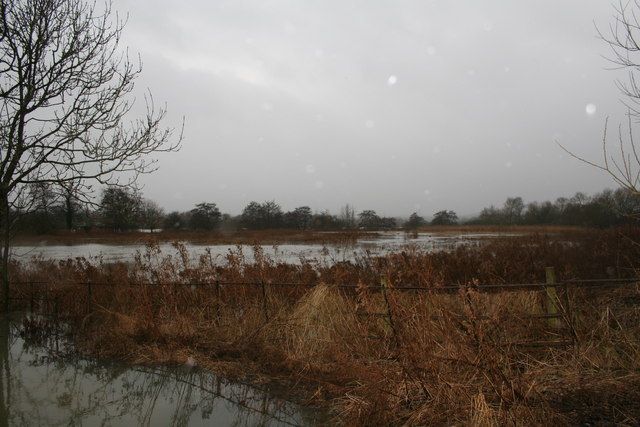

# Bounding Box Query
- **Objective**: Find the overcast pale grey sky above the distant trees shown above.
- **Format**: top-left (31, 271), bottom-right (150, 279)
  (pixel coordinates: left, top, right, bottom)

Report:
top-left (114, 0), bottom-right (624, 217)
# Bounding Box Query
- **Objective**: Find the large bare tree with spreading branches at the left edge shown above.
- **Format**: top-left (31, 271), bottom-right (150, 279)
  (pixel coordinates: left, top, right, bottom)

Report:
top-left (0, 0), bottom-right (182, 308)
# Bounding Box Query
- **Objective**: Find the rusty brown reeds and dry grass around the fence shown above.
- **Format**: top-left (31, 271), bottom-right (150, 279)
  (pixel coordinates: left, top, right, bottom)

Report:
top-left (5, 229), bottom-right (640, 425)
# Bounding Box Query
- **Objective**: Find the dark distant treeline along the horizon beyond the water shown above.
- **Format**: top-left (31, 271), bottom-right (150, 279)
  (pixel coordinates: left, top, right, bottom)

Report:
top-left (16, 187), bottom-right (640, 234)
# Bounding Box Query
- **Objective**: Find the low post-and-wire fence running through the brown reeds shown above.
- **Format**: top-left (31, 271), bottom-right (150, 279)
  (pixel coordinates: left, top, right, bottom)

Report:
top-left (10, 267), bottom-right (640, 347)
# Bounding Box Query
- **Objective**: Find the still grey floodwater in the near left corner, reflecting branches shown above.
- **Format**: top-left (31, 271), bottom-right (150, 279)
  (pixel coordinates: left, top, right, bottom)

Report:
top-left (0, 316), bottom-right (328, 426)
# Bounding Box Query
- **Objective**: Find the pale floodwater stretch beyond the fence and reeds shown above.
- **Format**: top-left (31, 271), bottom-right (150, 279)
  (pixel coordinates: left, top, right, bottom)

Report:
top-left (12, 232), bottom-right (509, 264)
